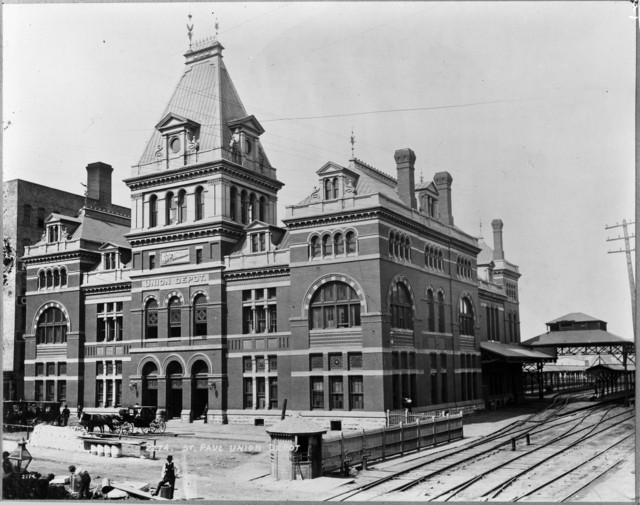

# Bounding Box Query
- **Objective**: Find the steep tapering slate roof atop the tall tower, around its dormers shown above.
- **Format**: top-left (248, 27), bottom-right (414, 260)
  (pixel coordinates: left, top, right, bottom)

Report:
top-left (139, 41), bottom-right (247, 165)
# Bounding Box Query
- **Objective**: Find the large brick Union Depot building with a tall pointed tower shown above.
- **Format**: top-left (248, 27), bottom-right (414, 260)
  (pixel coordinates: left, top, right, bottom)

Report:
top-left (18, 34), bottom-right (519, 427)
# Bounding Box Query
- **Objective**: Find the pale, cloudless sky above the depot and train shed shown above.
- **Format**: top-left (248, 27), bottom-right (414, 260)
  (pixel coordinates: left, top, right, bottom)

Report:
top-left (3, 2), bottom-right (635, 340)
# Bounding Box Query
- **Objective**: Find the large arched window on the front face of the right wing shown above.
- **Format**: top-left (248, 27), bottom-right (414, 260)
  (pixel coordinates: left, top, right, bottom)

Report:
top-left (309, 282), bottom-right (360, 330)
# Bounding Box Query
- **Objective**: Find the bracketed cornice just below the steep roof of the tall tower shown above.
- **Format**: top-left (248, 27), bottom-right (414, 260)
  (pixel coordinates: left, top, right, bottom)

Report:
top-left (124, 160), bottom-right (284, 191)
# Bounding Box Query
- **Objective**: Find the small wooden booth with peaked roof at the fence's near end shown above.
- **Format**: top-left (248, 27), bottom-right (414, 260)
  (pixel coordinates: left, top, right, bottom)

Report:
top-left (267, 415), bottom-right (327, 480)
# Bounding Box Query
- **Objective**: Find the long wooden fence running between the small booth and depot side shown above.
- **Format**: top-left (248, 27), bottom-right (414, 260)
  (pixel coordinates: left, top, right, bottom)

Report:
top-left (322, 412), bottom-right (462, 472)
